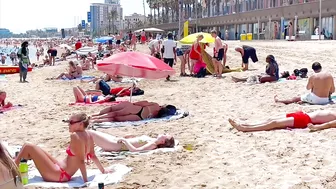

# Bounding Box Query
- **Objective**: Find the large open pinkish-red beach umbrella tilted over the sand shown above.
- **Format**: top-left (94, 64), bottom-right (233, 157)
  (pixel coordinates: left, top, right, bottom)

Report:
top-left (97, 51), bottom-right (175, 79)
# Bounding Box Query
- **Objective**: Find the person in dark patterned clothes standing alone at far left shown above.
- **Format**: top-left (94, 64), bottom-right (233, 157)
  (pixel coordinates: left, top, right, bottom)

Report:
top-left (17, 41), bottom-right (30, 83)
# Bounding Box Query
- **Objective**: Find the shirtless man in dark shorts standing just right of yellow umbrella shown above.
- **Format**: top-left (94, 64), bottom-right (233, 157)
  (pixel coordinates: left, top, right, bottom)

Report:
top-left (211, 30), bottom-right (225, 78)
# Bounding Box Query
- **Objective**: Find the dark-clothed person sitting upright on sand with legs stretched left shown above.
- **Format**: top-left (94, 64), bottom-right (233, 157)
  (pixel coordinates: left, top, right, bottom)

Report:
top-left (232, 55), bottom-right (279, 83)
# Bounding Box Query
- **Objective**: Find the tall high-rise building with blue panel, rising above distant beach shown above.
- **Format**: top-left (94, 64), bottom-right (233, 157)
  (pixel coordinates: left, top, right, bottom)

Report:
top-left (90, 0), bottom-right (123, 35)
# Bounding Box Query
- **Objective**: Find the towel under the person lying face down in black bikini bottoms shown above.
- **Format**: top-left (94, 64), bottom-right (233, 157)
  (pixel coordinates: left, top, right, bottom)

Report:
top-left (92, 110), bottom-right (189, 129)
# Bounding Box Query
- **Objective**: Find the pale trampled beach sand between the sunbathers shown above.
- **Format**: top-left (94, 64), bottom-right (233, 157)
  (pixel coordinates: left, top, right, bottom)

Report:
top-left (0, 41), bottom-right (336, 189)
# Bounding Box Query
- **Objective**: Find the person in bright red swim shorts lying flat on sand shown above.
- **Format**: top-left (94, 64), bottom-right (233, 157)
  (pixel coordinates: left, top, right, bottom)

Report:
top-left (229, 110), bottom-right (336, 132)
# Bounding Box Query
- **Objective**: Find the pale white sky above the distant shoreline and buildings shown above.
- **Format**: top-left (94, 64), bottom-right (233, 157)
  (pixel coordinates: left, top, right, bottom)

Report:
top-left (0, 0), bottom-right (149, 33)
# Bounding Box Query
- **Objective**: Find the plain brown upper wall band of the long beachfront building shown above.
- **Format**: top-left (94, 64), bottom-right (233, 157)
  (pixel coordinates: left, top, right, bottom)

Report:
top-left (153, 0), bottom-right (336, 30)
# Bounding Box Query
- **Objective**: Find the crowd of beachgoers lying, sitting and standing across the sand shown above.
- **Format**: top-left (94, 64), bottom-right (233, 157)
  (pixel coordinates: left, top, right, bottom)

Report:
top-left (0, 30), bottom-right (336, 188)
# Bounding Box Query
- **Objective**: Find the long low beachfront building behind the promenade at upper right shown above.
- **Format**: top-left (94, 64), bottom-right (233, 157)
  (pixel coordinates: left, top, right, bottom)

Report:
top-left (147, 0), bottom-right (336, 39)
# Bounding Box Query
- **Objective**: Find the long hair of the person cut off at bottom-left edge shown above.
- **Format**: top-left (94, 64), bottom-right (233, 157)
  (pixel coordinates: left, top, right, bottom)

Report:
top-left (0, 142), bottom-right (20, 184)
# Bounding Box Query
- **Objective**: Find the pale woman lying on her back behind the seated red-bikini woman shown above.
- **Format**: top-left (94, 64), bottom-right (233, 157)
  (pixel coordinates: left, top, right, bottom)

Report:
top-left (88, 131), bottom-right (175, 152)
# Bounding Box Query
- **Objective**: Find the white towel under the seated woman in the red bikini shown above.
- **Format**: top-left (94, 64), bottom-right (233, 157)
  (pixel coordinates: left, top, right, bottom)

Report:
top-left (25, 164), bottom-right (132, 188)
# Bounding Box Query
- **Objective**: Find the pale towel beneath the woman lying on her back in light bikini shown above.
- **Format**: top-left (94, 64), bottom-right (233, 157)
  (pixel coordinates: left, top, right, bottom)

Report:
top-left (95, 139), bottom-right (183, 160)
